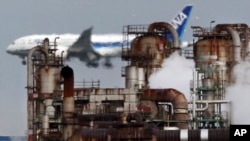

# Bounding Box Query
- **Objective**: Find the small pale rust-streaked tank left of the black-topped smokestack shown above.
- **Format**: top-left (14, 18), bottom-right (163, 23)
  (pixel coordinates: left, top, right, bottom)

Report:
top-left (40, 67), bottom-right (59, 93)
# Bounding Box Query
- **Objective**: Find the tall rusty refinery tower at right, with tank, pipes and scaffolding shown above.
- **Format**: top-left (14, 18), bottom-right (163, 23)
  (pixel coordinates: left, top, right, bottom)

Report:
top-left (188, 23), bottom-right (250, 128)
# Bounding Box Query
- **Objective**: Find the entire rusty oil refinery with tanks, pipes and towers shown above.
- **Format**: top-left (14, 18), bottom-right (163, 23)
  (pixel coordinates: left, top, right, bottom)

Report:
top-left (23, 22), bottom-right (250, 141)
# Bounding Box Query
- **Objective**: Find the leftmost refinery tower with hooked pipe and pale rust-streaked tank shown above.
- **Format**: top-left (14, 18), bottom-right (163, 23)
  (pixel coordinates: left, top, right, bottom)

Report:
top-left (27, 38), bottom-right (63, 141)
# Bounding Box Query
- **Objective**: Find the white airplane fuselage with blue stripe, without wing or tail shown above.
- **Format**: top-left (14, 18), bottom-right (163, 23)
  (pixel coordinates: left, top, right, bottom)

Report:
top-left (6, 34), bottom-right (122, 57)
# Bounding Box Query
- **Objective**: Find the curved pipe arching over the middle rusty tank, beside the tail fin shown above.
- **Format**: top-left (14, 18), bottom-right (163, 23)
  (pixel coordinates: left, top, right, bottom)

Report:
top-left (148, 22), bottom-right (180, 48)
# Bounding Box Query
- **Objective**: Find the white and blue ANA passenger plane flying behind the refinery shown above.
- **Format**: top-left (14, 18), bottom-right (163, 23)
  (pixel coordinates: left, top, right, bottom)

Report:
top-left (6, 5), bottom-right (193, 67)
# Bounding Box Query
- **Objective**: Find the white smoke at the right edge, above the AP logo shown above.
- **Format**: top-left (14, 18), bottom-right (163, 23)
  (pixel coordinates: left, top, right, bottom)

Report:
top-left (226, 62), bottom-right (250, 124)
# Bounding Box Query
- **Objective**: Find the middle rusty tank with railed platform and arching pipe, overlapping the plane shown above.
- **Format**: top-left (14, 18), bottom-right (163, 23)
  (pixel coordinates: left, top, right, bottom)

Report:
top-left (122, 22), bottom-right (180, 88)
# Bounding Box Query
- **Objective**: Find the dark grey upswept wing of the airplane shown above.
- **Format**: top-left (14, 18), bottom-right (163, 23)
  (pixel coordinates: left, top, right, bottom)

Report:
top-left (68, 27), bottom-right (101, 64)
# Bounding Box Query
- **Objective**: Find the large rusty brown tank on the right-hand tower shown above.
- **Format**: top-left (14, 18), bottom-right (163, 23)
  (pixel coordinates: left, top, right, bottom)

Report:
top-left (194, 39), bottom-right (234, 81)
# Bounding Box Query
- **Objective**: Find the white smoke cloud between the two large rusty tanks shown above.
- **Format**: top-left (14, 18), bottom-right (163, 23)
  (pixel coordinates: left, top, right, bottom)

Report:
top-left (149, 52), bottom-right (194, 100)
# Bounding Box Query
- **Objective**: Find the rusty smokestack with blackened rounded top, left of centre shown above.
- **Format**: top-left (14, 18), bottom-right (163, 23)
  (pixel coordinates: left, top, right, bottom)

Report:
top-left (61, 66), bottom-right (74, 140)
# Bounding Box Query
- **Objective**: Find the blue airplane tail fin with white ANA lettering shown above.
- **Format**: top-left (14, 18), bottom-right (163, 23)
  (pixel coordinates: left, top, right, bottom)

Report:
top-left (170, 4), bottom-right (193, 41)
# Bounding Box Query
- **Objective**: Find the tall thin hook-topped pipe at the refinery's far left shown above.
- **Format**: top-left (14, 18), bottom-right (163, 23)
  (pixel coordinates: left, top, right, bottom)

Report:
top-left (27, 46), bottom-right (49, 140)
